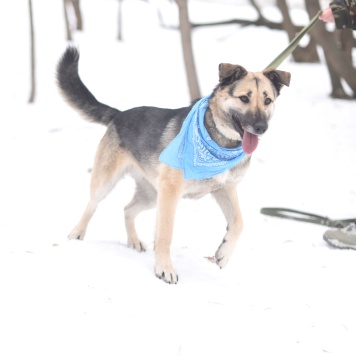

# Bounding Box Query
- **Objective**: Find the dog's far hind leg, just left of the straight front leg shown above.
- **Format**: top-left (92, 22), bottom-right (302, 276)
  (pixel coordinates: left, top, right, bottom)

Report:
top-left (125, 178), bottom-right (157, 252)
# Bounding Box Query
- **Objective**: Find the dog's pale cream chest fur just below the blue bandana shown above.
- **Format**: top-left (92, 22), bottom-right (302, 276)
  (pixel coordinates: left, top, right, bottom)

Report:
top-left (183, 157), bottom-right (250, 199)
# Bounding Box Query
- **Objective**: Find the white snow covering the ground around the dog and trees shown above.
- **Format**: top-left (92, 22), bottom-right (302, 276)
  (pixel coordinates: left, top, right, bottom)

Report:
top-left (0, 0), bottom-right (356, 356)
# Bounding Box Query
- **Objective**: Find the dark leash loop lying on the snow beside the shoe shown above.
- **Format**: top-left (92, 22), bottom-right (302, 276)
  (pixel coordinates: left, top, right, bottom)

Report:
top-left (260, 208), bottom-right (356, 228)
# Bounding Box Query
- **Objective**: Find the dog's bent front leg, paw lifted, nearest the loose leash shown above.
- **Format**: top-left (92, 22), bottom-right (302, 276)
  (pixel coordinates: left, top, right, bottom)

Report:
top-left (213, 186), bottom-right (243, 268)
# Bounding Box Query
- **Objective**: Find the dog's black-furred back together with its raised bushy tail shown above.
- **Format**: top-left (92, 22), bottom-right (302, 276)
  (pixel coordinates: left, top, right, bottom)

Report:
top-left (57, 47), bottom-right (190, 162)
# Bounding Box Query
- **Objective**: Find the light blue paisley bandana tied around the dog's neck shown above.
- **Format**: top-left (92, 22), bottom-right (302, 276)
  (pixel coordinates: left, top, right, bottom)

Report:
top-left (159, 95), bottom-right (246, 180)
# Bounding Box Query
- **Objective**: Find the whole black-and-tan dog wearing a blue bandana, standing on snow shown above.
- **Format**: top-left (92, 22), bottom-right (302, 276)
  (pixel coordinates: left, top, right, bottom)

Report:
top-left (57, 46), bottom-right (291, 284)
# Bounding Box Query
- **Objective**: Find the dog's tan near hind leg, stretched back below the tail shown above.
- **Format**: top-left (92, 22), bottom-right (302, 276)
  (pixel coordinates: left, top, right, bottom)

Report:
top-left (68, 131), bottom-right (129, 240)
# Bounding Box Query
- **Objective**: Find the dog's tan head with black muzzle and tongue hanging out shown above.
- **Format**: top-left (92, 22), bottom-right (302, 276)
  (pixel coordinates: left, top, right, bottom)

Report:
top-left (210, 63), bottom-right (291, 154)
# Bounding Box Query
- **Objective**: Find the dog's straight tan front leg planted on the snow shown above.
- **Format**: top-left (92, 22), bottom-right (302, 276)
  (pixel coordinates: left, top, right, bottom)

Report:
top-left (155, 166), bottom-right (183, 284)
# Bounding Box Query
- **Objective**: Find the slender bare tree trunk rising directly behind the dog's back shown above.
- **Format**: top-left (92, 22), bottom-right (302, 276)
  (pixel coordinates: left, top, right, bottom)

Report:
top-left (176, 0), bottom-right (201, 101)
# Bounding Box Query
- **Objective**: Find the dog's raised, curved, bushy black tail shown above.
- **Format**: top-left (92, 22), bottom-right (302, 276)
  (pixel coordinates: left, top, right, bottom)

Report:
top-left (57, 46), bottom-right (119, 125)
